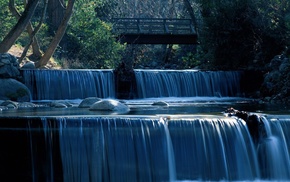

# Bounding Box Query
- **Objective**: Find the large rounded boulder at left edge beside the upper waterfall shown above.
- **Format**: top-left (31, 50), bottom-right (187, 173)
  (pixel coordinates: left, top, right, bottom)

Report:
top-left (0, 78), bottom-right (31, 102)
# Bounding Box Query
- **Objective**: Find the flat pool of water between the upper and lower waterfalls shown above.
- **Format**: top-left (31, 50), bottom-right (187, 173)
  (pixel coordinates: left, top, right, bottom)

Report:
top-left (0, 97), bottom-right (290, 117)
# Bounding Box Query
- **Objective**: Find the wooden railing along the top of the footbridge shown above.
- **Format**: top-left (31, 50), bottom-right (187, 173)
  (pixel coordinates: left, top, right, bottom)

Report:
top-left (113, 18), bottom-right (196, 34)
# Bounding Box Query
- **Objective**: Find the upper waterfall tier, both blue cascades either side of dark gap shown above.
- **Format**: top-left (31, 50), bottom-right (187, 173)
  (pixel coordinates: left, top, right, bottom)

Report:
top-left (23, 70), bottom-right (242, 100)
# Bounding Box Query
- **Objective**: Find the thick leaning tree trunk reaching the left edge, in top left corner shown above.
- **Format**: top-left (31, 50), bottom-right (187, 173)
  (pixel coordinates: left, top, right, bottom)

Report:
top-left (0, 0), bottom-right (39, 53)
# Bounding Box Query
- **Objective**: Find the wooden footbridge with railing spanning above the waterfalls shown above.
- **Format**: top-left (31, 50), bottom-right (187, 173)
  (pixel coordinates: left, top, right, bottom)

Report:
top-left (113, 18), bottom-right (197, 44)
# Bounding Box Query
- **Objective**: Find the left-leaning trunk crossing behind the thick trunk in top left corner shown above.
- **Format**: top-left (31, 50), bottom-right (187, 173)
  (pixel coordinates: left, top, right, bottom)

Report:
top-left (9, 0), bottom-right (42, 58)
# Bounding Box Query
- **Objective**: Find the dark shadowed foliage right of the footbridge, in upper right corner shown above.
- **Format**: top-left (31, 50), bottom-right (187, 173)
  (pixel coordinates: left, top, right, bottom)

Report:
top-left (199, 0), bottom-right (289, 69)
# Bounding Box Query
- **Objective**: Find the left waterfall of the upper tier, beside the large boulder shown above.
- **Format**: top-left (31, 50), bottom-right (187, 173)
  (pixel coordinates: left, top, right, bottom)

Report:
top-left (23, 70), bottom-right (115, 100)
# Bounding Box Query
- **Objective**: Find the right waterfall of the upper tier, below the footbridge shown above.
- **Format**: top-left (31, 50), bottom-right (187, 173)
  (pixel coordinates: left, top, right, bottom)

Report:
top-left (135, 70), bottom-right (241, 98)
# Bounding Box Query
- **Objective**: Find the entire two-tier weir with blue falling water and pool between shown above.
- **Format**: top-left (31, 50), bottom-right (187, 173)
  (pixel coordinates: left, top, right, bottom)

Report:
top-left (0, 70), bottom-right (290, 182)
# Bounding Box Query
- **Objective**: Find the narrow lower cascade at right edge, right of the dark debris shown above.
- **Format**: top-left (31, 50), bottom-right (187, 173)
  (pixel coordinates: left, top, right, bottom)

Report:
top-left (258, 117), bottom-right (290, 180)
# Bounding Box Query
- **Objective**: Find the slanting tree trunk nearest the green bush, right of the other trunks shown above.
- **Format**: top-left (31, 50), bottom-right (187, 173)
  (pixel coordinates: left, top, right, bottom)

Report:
top-left (35, 0), bottom-right (75, 68)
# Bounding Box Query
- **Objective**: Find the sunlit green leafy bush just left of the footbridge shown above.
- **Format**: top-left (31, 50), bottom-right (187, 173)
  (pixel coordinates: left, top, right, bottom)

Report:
top-left (68, 0), bottom-right (123, 68)
